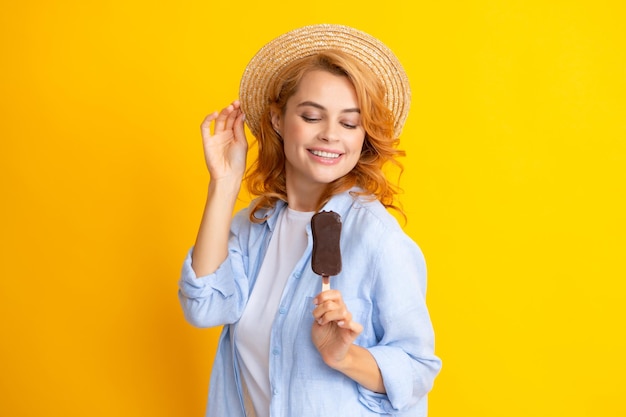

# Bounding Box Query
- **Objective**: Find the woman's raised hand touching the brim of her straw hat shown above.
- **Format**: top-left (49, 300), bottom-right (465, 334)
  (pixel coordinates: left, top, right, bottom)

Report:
top-left (201, 101), bottom-right (248, 182)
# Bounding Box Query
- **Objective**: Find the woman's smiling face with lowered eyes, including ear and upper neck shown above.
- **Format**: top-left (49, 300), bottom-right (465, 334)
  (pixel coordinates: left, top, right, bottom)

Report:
top-left (272, 70), bottom-right (365, 197)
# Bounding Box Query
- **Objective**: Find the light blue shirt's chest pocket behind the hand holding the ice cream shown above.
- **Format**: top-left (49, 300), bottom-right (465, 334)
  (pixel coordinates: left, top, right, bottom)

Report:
top-left (293, 297), bottom-right (372, 380)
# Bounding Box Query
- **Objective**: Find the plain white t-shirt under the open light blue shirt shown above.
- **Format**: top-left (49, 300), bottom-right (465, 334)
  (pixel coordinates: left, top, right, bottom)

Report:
top-left (235, 207), bottom-right (314, 417)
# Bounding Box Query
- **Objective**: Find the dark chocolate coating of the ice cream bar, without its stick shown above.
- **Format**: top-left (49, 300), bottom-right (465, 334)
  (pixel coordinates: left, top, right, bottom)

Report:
top-left (311, 211), bottom-right (341, 276)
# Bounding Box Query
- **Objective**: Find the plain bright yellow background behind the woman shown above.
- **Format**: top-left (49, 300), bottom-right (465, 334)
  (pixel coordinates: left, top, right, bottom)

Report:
top-left (0, 0), bottom-right (626, 417)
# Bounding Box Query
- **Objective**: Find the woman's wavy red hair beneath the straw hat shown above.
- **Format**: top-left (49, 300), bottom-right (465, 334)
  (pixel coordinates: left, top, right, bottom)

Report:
top-left (246, 51), bottom-right (405, 222)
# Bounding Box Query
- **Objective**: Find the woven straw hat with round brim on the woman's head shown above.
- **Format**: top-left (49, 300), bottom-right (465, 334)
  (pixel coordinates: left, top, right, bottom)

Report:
top-left (239, 24), bottom-right (411, 137)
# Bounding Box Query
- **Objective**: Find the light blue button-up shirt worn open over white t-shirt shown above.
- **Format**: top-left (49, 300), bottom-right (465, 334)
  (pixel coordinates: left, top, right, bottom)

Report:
top-left (179, 192), bottom-right (441, 417)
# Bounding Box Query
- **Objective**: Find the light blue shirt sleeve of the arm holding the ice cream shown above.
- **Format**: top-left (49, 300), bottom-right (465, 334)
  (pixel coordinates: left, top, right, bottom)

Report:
top-left (359, 233), bottom-right (441, 414)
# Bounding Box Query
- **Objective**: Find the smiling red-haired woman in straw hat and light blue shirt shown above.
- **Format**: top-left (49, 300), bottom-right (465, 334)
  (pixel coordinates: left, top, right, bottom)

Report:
top-left (179, 25), bottom-right (441, 417)
